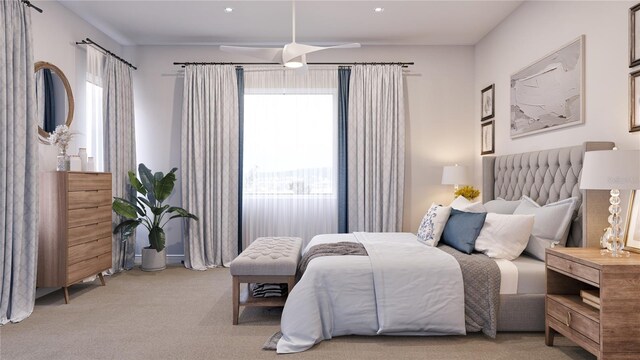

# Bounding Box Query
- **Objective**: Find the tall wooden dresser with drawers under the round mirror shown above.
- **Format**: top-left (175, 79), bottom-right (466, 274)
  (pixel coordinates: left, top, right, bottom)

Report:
top-left (37, 171), bottom-right (112, 303)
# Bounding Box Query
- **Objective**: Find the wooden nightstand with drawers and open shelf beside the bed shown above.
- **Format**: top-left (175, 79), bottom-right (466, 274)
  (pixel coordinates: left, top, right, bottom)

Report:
top-left (545, 248), bottom-right (640, 360)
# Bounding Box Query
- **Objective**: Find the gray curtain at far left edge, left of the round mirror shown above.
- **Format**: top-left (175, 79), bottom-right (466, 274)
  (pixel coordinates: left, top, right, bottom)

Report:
top-left (0, 0), bottom-right (38, 324)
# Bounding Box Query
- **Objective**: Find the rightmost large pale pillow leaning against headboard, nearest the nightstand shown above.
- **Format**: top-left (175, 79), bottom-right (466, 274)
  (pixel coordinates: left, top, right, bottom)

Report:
top-left (513, 196), bottom-right (578, 260)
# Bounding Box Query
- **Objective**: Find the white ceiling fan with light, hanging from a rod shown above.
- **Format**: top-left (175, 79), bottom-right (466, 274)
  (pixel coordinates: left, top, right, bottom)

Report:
top-left (220, 1), bottom-right (360, 68)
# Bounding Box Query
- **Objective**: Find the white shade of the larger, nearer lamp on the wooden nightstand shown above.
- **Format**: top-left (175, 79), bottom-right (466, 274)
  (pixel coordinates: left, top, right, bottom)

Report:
top-left (580, 150), bottom-right (640, 190)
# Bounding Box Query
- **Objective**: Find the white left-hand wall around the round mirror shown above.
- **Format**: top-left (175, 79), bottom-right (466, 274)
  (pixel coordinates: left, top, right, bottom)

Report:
top-left (31, 1), bottom-right (122, 171)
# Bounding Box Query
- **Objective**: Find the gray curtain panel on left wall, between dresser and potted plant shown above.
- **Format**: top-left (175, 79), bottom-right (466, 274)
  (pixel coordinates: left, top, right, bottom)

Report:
top-left (102, 55), bottom-right (137, 274)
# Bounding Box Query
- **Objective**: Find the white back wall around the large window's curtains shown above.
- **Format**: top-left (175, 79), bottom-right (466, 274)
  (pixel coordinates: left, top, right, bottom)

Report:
top-left (134, 46), bottom-right (477, 255)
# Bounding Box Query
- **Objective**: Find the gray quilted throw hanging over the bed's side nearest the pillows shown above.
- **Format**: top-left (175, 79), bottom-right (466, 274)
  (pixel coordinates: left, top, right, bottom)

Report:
top-left (438, 244), bottom-right (500, 338)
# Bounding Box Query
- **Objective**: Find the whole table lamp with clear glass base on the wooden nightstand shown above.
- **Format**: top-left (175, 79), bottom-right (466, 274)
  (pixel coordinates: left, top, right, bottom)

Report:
top-left (580, 148), bottom-right (640, 257)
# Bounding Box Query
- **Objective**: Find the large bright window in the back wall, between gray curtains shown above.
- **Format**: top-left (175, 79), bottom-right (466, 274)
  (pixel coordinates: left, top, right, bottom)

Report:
top-left (243, 93), bottom-right (336, 196)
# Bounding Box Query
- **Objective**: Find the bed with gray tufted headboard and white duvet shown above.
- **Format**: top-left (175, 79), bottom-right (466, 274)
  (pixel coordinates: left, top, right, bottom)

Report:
top-left (277, 142), bottom-right (613, 353)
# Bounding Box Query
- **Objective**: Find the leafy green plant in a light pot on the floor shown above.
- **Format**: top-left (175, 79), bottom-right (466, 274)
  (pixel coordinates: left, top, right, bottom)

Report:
top-left (112, 163), bottom-right (198, 271)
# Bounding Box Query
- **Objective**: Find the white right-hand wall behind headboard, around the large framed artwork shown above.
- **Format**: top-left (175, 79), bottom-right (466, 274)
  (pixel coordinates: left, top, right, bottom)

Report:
top-left (473, 1), bottom-right (640, 187)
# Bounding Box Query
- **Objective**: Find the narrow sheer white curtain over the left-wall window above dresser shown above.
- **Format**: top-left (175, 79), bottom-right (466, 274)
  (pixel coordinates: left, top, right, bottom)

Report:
top-left (85, 46), bottom-right (106, 171)
